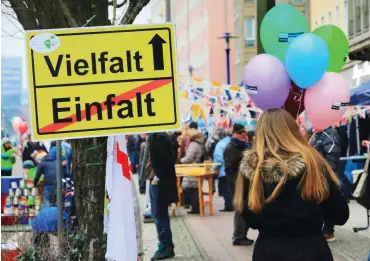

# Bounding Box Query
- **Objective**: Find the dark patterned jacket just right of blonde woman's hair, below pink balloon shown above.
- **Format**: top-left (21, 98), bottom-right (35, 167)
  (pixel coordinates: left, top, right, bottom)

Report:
top-left (313, 127), bottom-right (341, 174)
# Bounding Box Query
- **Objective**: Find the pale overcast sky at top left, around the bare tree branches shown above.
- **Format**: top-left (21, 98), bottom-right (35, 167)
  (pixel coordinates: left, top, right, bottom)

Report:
top-left (1, 1), bottom-right (151, 87)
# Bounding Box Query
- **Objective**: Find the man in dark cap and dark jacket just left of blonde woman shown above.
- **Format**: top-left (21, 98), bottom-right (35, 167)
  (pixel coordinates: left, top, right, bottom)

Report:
top-left (224, 124), bottom-right (253, 246)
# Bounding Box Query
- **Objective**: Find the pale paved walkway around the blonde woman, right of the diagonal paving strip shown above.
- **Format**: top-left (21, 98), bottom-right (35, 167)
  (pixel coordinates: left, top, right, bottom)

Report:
top-left (180, 182), bottom-right (370, 261)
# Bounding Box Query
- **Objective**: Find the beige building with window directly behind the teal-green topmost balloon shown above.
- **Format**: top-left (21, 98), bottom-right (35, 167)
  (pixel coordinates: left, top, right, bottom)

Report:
top-left (233, 0), bottom-right (310, 83)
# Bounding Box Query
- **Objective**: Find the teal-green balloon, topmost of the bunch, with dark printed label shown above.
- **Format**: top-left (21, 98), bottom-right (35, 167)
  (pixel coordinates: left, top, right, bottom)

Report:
top-left (260, 4), bottom-right (310, 62)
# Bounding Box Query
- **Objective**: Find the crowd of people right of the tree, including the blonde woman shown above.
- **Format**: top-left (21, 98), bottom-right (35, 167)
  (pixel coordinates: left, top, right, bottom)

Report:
top-left (130, 109), bottom-right (368, 261)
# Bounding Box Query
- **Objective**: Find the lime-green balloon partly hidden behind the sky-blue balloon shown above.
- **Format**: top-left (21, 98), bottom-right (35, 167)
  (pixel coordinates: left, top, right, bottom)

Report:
top-left (312, 25), bottom-right (349, 72)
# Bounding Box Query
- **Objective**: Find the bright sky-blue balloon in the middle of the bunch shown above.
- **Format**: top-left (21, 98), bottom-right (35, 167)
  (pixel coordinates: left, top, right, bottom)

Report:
top-left (285, 33), bottom-right (329, 89)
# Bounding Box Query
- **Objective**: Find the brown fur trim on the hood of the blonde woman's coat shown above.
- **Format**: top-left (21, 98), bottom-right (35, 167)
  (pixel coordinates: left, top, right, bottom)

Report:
top-left (240, 151), bottom-right (306, 183)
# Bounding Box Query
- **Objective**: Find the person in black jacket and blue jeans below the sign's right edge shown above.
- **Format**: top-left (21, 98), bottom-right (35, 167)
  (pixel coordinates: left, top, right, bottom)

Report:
top-left (146, 133), bottom-right (178, 260)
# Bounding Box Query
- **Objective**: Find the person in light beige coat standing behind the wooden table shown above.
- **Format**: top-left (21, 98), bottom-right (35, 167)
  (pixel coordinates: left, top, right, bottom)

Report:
top-left (180, 127), bottom-right (205, 214)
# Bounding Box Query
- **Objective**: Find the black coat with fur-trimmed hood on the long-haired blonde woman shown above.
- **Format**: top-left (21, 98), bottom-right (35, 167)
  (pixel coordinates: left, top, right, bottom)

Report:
top-left (240, 153), bottom-right (349, 261)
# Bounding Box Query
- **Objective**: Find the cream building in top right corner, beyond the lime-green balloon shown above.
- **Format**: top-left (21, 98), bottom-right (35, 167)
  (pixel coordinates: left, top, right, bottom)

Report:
top-left (310, 0), bottom-right (370, 88)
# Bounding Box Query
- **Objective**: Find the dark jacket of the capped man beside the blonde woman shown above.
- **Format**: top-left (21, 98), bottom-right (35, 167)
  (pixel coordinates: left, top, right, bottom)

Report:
top-left (224, 139), bottom-right (245, 197)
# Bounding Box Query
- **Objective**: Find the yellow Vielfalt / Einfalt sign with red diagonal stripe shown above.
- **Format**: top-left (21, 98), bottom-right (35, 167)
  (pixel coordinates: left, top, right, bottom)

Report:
top-left (26, 24), bottom-right (181, 140)
